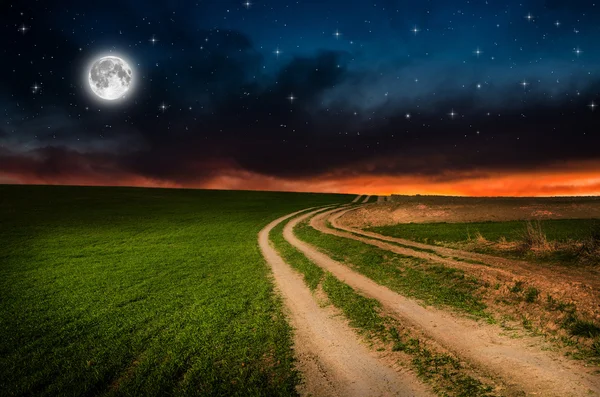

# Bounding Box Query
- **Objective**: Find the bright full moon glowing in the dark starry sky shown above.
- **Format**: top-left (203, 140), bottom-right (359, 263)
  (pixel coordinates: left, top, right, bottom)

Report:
top-left (89, 56), bottom-right (133, 101)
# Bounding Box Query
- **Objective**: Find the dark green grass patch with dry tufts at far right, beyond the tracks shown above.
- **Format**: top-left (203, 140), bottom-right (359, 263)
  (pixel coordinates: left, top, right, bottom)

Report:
top-left (367, 219), bottom-right (600, 265)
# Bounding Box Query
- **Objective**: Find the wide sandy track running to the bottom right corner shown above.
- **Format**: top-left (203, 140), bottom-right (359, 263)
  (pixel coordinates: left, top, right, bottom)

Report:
top-left (284, 211), bottom-right (600, 397)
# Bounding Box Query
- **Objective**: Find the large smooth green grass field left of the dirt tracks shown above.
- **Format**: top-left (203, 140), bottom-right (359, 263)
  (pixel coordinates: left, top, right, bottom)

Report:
top-left (0, 186), bottom-right (352, 396)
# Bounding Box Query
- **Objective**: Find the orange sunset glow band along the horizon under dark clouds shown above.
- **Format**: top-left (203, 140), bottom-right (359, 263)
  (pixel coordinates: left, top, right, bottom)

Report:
top-left (0, 158), bottom-right (600, 197)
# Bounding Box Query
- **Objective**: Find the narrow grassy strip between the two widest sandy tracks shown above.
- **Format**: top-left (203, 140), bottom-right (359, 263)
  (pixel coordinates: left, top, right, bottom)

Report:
top-left (269, 215), bottom-right (492, 397)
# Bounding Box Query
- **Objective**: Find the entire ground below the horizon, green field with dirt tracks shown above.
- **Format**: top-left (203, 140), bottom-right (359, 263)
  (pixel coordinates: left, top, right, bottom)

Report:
top-left (0, 186), bottom-right (600, 397)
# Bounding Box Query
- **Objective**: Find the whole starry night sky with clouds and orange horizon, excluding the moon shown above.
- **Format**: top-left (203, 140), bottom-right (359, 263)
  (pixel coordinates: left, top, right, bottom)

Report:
top-left (0, 0), bottom-right (600, 195)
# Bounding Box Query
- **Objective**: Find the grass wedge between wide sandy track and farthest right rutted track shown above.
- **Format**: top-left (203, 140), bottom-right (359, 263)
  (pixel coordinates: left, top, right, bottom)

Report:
top-left (295, 218), bottom-right (489, 318)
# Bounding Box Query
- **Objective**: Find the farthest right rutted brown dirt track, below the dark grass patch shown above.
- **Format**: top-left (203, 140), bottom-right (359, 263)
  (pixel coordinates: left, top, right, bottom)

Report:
top-left (328, 208), bottom-right (600, 292)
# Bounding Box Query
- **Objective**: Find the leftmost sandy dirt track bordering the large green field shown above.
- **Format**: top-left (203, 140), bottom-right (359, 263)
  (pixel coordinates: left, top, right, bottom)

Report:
top-left (258, 209), bottom-right (433, 397)
